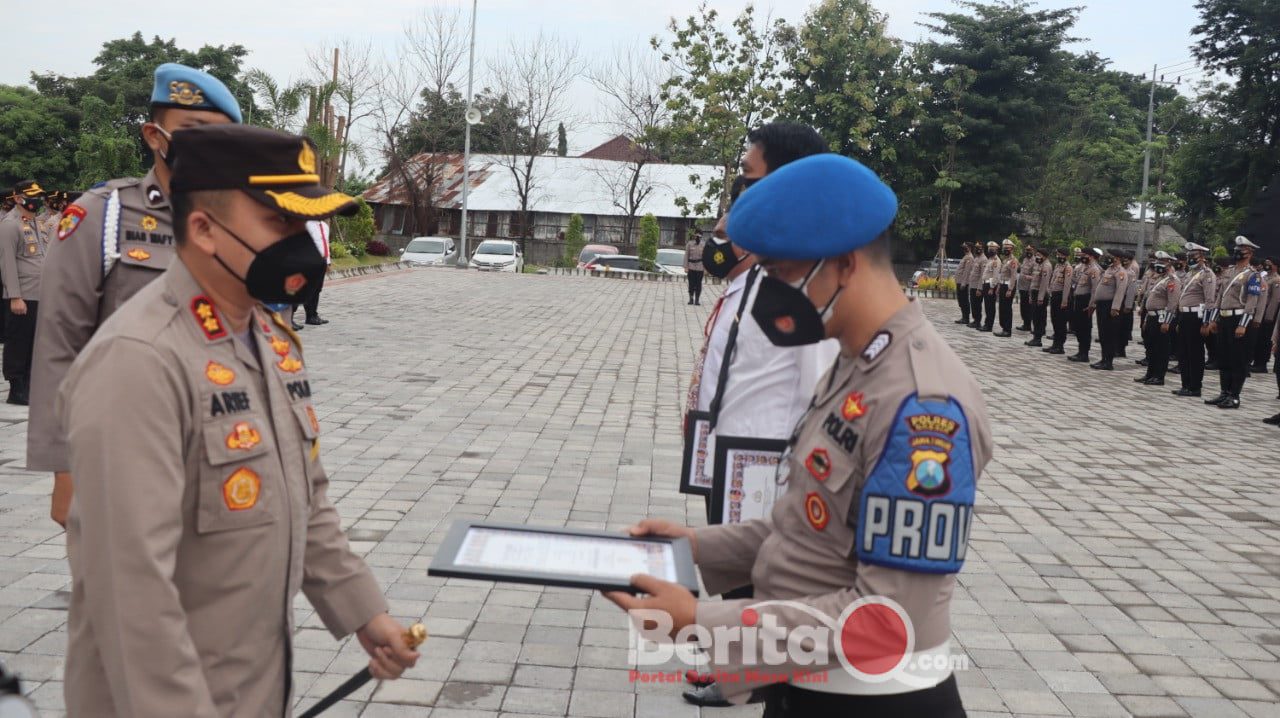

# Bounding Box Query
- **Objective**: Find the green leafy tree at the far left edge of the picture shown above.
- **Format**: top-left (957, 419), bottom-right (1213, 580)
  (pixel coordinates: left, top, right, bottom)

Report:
top-left (0, 84), bottom-right (79, 188)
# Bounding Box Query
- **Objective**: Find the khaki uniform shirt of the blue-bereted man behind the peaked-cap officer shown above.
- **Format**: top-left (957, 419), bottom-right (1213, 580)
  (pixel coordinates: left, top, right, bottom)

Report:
top-left (27, 172), bottom-right (174, 471)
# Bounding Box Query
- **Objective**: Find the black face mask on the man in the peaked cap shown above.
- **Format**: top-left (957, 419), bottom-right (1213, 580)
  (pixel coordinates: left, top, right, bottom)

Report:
top-left (209, 216), bottom-right (325, 305)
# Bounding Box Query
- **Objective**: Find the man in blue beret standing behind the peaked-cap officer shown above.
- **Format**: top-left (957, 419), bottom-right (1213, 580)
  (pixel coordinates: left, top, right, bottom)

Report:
top-left (27, 63), bottom-right (241, 525)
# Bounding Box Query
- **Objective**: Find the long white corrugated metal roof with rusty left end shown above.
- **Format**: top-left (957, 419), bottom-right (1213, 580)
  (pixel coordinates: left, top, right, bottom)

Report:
top-left (362, 154), bottom-right (721, 218)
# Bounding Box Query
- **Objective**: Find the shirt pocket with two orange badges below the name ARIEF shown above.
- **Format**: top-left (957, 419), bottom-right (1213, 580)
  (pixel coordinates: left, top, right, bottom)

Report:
top-left (196, 416), bottom-right (278, 534)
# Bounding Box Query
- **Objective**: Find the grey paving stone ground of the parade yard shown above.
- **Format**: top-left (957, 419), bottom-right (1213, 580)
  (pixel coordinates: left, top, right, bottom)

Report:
top-left (0, 269), bottom-right (1280, 718)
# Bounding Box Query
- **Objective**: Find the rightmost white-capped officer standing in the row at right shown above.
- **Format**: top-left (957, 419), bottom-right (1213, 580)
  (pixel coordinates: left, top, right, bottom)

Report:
top-left (1204, 237), bottom-right (1262, 408)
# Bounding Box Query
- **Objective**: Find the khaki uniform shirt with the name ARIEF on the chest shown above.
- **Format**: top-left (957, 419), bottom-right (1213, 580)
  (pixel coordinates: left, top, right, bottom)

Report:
top-left (58, 261), bottom-right (387, 717)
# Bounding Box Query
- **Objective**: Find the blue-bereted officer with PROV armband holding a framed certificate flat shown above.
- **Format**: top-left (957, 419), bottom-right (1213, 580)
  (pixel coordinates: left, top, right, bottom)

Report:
top-left (607, 155), bottom-right (992, 718)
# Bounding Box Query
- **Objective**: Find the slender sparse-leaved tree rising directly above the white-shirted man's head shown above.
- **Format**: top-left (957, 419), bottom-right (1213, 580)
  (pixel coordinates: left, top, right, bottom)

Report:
top-left (652, 1), bottom-right (781, 216)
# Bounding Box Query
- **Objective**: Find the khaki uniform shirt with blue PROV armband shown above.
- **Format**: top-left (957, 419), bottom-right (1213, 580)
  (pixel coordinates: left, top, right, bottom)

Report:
top-left (696, 302), bottom-right (992, 700)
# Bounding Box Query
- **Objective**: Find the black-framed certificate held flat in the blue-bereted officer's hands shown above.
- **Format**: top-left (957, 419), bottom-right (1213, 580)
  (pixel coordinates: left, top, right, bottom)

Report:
top-left (426, 521), bottom-right (698, 595)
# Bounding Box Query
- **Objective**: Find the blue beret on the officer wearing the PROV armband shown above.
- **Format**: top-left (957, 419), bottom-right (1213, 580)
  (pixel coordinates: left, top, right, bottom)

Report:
top-left (726, 154), bottom-right (897, 260)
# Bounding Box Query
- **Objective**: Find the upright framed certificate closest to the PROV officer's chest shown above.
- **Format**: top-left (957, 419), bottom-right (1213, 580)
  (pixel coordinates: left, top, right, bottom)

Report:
top-left (710, 436), bottom-right (787, 523)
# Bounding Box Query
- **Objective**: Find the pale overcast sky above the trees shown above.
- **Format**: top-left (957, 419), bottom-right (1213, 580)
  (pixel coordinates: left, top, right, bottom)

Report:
top-left (0, 0), bottom-right (1198, 174)
